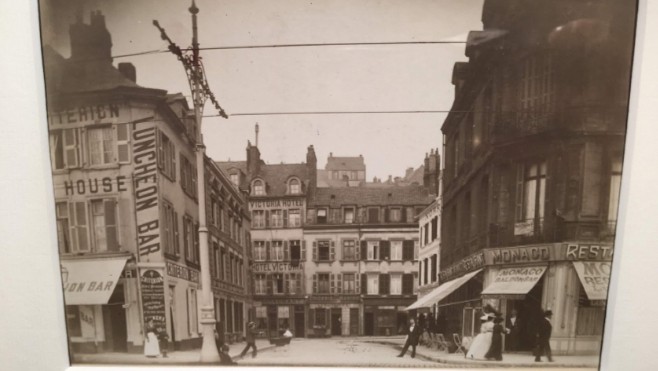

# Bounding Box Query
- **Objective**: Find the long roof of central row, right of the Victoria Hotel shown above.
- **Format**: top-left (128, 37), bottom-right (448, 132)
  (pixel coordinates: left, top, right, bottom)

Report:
top-left (309, 185), bottom-right (434, 206)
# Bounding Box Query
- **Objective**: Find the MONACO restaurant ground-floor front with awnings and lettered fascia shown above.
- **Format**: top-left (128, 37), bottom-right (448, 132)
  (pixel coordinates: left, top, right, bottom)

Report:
top-left (407, 243), bottom-right (612, 354)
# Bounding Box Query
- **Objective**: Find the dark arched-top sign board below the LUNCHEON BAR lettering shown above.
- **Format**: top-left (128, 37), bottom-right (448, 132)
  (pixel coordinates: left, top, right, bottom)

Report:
top-left (139, 268), bottom-right (166, 328)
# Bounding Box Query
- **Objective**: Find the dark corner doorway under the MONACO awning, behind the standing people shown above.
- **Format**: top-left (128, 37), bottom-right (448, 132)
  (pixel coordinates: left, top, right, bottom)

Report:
top-left (505, 277), bottom-right (544, 352)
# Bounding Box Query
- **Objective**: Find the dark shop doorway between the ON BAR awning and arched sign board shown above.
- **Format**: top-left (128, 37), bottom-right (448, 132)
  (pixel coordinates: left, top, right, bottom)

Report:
top-left (103, 284), bottom-right (128, 352)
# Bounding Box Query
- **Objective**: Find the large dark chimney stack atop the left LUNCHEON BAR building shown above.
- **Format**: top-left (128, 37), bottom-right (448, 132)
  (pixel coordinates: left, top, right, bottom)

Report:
top-left (69, 11), bottom-right (112, 63)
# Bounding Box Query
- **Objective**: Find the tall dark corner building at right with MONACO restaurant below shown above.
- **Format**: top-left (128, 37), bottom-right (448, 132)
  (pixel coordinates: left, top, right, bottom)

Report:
top-left (439, 0), bottom-right (634, 354)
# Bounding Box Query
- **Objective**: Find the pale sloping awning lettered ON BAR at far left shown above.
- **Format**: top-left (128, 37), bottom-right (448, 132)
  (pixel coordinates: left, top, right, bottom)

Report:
top-left (61, 256), bottom-right (128, 305)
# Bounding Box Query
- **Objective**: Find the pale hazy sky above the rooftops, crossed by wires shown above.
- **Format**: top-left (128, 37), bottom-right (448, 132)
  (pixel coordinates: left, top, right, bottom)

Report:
top-left (41, 0), bottom-right (482, 181)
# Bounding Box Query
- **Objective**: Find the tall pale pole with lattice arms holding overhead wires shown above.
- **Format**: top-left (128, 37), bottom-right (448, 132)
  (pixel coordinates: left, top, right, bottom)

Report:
top-left (153, 0), bottom-right (228, 363)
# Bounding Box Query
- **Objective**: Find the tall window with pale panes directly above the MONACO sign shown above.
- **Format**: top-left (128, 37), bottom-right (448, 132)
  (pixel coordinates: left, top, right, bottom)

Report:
top-left (516, 161), bottom-right (546, 231)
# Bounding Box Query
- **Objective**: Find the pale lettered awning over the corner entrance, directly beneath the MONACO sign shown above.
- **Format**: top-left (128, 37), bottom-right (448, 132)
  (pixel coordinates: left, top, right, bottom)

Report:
top-left (482, 265), bottom-right (546, 299)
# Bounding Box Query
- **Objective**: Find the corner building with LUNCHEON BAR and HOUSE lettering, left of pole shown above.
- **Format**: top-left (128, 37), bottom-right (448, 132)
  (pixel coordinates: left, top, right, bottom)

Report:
top-left (44, 13), bottom-right (248, 353)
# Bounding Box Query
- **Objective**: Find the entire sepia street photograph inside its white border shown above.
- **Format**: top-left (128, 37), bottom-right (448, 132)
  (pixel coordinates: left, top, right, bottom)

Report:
top-left (39, 0), bottom-right (638, 369)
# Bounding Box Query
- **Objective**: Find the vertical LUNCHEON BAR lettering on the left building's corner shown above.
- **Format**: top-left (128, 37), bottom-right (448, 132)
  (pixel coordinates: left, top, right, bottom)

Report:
top-left (132, 123), bottom-right (162, 262)
